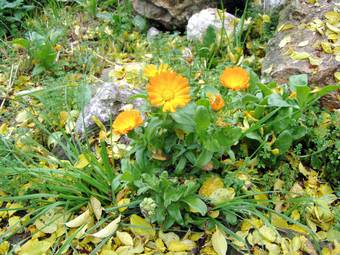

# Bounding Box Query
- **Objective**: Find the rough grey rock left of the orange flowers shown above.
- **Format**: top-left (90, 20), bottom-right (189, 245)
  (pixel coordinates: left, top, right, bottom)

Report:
top-left (76, 81), bottom-right (143, 134)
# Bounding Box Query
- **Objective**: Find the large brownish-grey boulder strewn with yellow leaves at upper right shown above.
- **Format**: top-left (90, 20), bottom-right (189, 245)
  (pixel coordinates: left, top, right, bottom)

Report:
top-left (262, 0), bottom-right (340, 109)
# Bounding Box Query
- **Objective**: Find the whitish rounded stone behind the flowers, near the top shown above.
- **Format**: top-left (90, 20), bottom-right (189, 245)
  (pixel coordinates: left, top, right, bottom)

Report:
top-left (187, 8), bottom-right (237, 41)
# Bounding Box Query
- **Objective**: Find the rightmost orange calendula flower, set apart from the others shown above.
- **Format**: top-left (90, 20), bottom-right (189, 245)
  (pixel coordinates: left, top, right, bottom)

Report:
top-left (220, 67), bottom-right (249, 90)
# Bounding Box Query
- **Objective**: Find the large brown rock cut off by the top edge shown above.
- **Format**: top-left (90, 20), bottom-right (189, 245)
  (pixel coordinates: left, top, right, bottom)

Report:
top-left (132, 0), bottom-right (219, 29)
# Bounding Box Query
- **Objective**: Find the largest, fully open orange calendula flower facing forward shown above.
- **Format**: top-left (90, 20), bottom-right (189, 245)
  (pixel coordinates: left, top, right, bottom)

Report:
top-left (147, 72), bottom-right (190, 112)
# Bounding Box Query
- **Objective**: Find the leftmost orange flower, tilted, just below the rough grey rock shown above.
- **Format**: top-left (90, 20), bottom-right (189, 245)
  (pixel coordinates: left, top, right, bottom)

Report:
top-left (112, 110), bottom-right (143, 135)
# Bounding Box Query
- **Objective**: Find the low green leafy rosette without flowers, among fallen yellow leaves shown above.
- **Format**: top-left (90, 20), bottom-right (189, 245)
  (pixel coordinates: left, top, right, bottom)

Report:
top-left (122, 169), bottom-right (207, 230)
